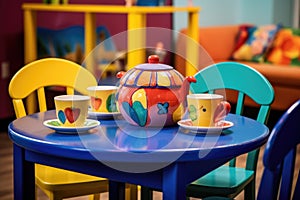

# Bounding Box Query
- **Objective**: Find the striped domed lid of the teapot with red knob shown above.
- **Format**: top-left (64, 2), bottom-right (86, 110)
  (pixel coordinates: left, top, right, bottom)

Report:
top-left (120, 55), bottom-right (184, 88)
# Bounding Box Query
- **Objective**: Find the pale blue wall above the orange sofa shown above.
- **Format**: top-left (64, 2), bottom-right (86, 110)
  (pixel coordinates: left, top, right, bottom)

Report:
top-left (173, 0), bottom-right (293, 30)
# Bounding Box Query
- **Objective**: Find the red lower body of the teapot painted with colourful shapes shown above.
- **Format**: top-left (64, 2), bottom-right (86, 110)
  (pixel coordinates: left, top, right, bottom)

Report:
top-left (118, 88), bottom-right (183, 126)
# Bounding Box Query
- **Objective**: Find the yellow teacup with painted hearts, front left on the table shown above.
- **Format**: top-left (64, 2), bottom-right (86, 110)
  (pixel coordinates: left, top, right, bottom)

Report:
top-left (54, 95), bottom-right (90, 127)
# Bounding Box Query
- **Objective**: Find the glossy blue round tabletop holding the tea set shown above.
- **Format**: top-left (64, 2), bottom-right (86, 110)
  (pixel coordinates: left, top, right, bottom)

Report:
top-left (9, 111), bottom-right (269, 163)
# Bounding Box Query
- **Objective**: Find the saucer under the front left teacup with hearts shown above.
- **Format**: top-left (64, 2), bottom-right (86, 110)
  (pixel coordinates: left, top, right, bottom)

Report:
top-left (43, 119), bottom-right (100, 134)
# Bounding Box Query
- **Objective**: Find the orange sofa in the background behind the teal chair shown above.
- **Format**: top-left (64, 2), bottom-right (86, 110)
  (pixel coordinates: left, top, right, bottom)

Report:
top-left (174, 25), bottom-right (300, 111)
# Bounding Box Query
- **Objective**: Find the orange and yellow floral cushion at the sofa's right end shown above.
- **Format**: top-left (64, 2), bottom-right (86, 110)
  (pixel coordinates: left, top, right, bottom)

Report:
top-left (266, 28), bottom-right (300, 65)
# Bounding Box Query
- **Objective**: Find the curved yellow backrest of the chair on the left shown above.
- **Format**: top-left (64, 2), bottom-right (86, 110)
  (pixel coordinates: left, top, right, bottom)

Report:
top-left (8, 58), bottom-right (97, 118)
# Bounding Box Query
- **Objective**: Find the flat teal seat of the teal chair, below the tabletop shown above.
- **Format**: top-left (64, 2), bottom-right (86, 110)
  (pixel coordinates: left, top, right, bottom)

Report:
top-left (187, 165), bottom-right (254, 198)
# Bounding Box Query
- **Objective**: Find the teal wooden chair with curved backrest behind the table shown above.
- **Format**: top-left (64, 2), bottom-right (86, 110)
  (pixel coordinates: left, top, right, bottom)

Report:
top-left (187, 62), bottom-right (274, 199)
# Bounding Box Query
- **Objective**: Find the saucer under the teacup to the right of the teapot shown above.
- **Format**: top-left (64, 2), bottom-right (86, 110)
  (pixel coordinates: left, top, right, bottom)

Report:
top-left (177, 119), bottom-right (233, 134)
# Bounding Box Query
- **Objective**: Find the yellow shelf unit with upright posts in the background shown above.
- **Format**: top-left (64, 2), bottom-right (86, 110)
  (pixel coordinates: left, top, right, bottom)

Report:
top-left (22, 3), bottom-right (200, 113)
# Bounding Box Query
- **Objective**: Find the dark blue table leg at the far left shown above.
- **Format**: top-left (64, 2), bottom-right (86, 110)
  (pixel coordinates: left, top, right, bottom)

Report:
top-left (13, 144), bottom-right (35, 200)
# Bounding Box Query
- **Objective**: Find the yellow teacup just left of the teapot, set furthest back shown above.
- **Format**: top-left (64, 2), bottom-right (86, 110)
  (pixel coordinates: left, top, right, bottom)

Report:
top-left (87, 85), bottom-right (118, 113)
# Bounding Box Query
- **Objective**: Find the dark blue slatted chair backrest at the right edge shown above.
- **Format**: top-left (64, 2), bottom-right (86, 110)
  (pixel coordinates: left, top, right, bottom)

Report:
top-left (258, 100), bottom-right (300, 200)
